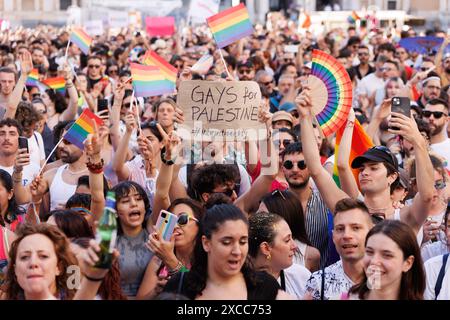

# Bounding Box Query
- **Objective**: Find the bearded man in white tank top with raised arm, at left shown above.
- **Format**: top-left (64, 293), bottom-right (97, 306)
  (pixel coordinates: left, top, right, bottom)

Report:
top-left (14, 121), bottom-right (89, 210)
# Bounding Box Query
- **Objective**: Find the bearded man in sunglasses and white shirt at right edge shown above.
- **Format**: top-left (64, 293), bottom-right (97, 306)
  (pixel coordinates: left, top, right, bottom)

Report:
top-left (422, 99), bottom-right (450, 170)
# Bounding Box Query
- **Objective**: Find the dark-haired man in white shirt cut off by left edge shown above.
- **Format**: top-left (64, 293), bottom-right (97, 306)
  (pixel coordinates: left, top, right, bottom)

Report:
top-left (0, 118), bottom-right (39, 186)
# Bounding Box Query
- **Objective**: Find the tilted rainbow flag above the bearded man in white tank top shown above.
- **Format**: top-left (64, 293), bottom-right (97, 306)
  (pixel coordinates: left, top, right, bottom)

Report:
top-left (64, 108), bottom-right (103, 150)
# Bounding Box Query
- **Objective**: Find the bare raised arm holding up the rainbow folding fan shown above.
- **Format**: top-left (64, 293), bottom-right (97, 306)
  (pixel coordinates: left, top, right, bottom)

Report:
top-left (295, 86), bottom-right (348, 211)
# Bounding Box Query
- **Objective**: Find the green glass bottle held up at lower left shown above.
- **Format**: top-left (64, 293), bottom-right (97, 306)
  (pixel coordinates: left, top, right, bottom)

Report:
top-left (95, 191), bottom-right (117, 269)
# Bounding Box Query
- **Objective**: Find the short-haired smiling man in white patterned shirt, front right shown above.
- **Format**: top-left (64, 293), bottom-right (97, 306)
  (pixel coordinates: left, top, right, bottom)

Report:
top-left (305, 198), bottom-right (373, 300)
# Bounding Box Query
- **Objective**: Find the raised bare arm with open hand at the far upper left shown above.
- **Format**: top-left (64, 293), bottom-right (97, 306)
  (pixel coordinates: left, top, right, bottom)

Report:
top-left (5, 51), bottom-right (33, 119)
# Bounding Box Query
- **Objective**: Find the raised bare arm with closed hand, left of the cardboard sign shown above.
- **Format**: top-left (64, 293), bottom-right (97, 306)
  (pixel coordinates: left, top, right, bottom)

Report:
top-left (113, 111), bottom-right (137, 181)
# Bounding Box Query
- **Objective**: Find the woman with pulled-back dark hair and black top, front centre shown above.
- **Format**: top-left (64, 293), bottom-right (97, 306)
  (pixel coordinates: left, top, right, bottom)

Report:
top-left (164, 204), bottom-right (291, 300)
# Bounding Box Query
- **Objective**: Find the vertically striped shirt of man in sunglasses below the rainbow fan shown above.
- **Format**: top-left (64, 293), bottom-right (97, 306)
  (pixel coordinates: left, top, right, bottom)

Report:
top-left (305, 188), bottom-right (328, 268)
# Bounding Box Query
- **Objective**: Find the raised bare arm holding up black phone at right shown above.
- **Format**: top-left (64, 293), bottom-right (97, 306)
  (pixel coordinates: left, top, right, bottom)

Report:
top-left (389, 112), bottom-right (434, 233)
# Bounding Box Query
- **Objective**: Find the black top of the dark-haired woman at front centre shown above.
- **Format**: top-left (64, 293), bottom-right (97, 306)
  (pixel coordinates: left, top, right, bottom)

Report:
top-left (164, 271), bottom-right (281, 300)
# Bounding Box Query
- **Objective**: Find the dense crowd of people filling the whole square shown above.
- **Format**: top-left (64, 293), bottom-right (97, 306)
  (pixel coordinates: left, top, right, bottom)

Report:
top-left (0, 10), bottom-right (450, 300)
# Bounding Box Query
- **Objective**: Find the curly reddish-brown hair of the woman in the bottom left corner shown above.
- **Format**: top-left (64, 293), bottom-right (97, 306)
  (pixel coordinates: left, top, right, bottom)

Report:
top-left (5, 223), bottom-right (78, 300)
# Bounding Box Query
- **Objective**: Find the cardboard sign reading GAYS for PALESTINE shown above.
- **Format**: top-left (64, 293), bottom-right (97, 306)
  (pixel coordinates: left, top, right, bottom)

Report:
top-left (177, 80), bottom-right (266, 141)
